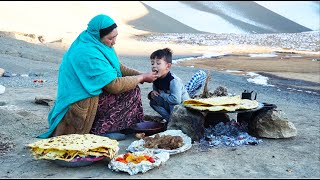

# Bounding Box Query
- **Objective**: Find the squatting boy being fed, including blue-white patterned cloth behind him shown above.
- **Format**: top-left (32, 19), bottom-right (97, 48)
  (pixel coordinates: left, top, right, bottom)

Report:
top-left (148, 48), bottom-right (206, 123)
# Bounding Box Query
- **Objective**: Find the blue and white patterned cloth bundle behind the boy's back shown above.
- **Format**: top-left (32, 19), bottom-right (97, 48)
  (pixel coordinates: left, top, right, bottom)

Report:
top-left (185, 70), bottom-right (207, 98)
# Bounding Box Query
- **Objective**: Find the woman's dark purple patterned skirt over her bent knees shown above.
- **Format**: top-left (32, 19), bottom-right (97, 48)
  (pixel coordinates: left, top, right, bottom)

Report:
top-left (90, 86), bottom-right (144, 135)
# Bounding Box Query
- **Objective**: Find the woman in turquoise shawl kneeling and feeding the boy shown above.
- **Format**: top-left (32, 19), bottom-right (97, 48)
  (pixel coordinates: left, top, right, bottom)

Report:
top-left (38, 14), bottom-right (157, 138)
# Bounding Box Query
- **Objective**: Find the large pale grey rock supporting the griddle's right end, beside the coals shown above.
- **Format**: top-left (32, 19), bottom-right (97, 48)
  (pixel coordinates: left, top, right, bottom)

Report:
top-left (250, 109), bottom-right (297, 138)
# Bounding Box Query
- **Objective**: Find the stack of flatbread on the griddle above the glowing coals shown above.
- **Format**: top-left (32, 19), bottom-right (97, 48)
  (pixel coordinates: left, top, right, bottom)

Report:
top-left (183, 95), bottom-right (259, 112)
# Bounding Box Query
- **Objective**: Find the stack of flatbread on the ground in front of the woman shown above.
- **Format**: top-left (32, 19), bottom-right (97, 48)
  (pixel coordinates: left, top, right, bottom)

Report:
top-left (27, 134), bottom-right (119, 161)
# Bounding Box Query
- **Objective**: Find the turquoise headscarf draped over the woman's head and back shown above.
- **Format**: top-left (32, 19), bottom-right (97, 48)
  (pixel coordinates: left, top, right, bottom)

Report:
top-left (38, 14), bottom-right (122, 138)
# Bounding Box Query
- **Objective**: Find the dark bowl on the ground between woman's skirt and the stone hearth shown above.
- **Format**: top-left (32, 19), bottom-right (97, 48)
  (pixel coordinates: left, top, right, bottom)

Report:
top-left (131, 121), bottom-right (166, 136)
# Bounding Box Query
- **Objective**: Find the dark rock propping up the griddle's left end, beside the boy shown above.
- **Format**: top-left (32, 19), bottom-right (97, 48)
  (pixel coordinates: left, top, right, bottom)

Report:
top-left (167, 104), bottom-right (205, 141)
